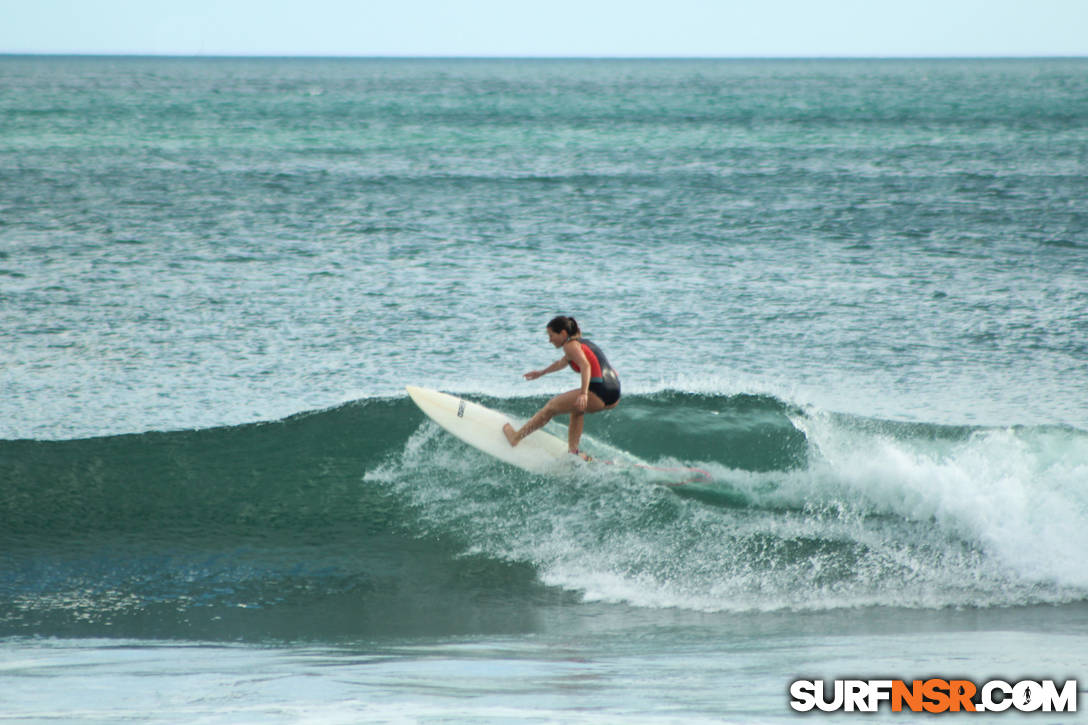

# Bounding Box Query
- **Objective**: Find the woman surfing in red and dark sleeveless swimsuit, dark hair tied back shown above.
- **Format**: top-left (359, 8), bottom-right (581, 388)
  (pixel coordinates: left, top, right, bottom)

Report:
top-left (503, 316), bottom-right (619, 455)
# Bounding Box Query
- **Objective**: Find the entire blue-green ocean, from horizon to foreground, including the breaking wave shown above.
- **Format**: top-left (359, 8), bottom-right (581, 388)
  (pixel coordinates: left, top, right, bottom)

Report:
top-left (0, 57), bottom-right (1088, 723)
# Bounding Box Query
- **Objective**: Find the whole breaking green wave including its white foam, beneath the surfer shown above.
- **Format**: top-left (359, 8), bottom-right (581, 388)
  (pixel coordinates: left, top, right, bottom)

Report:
top-left (0, 391), bottom-right (1088, 639)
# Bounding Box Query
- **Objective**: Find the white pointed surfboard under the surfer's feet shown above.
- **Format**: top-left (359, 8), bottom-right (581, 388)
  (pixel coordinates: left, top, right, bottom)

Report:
top-left (406, 385), bottom-right (578, 474)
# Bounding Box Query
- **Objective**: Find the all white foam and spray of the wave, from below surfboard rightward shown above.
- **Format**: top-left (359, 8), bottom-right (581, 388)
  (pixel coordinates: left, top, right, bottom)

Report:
top-left (391, 400), bottom-right (1088, 612)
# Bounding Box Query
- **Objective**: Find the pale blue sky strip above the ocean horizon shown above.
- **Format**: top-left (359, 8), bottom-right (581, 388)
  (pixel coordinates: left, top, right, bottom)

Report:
top-left (0, 0), bottom-right (1088, 58)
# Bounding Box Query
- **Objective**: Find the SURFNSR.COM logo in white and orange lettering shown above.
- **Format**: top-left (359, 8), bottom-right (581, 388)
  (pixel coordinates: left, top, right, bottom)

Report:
top-left (790, 677), bottom-right (1077, 713)
